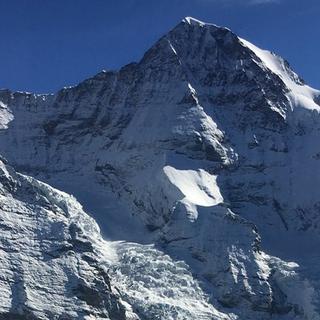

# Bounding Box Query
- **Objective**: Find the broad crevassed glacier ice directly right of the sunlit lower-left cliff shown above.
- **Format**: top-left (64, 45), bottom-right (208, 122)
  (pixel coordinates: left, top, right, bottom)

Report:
top-left (110, 242), bottom-right (233, 320)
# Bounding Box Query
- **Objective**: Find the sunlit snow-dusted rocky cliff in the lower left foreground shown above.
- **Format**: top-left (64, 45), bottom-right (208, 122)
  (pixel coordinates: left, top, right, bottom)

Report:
top-left (0, 162), bottom-right (126, 320)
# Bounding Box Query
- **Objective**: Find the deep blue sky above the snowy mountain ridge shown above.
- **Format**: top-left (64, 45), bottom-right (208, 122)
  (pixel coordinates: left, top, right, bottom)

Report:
top-left (0, 0), bottom-right (320, 93)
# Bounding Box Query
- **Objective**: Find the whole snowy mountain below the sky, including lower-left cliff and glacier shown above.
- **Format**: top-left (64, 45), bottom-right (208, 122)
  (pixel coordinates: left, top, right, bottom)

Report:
top-left (0, 18), bottom-right (320, 320)
